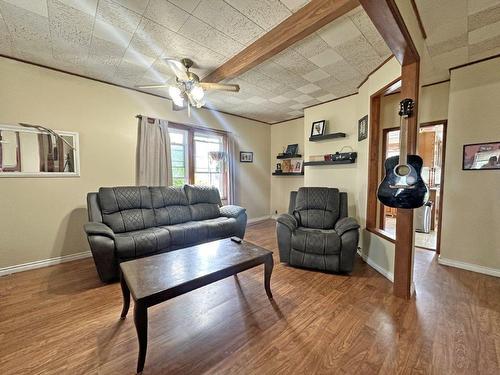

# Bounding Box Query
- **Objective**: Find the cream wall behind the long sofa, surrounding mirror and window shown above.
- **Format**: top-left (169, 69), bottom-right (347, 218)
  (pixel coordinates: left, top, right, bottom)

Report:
top-left (0, 58), bottom-right (271, 268)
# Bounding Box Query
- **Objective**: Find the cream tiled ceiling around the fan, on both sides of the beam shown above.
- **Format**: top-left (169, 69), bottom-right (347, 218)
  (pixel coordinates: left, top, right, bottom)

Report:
top-left (0, 0), bottom-right (391, 123)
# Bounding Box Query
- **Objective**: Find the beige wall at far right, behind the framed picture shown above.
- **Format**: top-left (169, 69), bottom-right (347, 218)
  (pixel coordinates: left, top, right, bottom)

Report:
top-left (441, 58), bottom-right (500, 276)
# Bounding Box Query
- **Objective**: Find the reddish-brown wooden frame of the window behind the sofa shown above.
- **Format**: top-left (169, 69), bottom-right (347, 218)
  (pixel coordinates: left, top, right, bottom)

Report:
top-left (168, 122), bottom-right (229, 201)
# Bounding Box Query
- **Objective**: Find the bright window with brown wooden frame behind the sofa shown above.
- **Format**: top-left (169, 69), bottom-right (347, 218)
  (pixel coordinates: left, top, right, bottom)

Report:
top-left (169, 124), bottom-right (228, 200)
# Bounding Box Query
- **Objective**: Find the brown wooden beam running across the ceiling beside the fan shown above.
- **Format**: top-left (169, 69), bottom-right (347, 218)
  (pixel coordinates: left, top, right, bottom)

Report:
top-left (203, 0), bottom-right (359, 82)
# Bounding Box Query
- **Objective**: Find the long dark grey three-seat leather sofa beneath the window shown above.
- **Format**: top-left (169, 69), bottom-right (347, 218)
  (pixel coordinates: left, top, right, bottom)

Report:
top-left (84, 185), bottom-right (247, 282)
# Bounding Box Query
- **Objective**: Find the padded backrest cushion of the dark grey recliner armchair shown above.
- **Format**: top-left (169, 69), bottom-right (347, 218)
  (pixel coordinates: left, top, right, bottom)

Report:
top-left (294, 187), bottom-right (340, 229)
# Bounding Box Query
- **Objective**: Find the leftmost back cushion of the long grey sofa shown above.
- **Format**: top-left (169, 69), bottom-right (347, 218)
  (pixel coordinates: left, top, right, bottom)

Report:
top-left (99, 186), bottom-right (155, 233)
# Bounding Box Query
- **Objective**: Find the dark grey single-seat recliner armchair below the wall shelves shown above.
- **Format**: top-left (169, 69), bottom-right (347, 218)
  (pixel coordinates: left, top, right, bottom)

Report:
top-left (276, 187), bottom-right (359, 272)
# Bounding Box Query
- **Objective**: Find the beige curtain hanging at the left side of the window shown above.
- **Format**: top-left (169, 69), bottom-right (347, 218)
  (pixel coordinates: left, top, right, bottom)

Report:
top-left (137, 117), bottom-right (172, 186)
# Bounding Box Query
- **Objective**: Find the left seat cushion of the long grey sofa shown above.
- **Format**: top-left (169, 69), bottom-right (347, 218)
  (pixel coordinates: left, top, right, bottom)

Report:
top-left (115, 228), bottom-right (171, 259)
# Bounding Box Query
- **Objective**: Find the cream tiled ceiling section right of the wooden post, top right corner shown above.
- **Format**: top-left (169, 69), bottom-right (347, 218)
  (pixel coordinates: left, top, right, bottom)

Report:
top-left (415, 0), bottom-right (500, 84)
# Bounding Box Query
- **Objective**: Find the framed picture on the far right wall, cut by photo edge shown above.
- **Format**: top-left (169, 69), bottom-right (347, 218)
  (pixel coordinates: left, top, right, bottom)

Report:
top-left (462, 141), bottom-right (500, 171)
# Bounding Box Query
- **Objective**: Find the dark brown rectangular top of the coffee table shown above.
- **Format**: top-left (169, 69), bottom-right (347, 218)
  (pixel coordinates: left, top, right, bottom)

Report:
top-left (120, 238), bottom-right (272, 301)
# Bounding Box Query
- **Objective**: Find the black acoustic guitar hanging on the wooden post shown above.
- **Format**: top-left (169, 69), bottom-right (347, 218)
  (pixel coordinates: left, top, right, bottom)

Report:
top-left (377, 99), bottom-right (429, 208)
